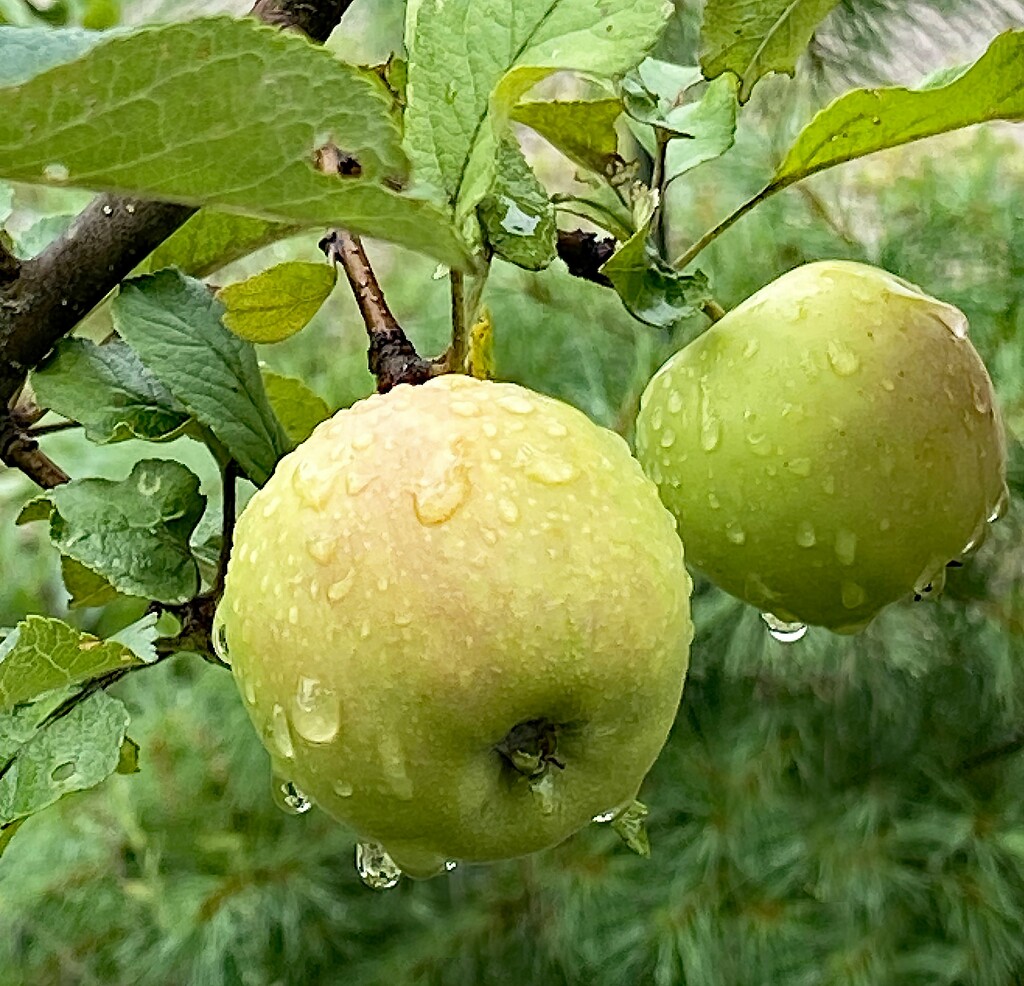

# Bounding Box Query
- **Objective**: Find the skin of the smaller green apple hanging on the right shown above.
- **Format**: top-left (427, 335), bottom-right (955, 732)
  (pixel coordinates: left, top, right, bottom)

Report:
top-left (637, 261), bottom-right (1006, 633)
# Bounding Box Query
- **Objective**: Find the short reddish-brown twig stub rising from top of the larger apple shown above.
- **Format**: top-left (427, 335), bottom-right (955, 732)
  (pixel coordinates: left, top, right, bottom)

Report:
top-left (319, 229), bottom-right (443, 393)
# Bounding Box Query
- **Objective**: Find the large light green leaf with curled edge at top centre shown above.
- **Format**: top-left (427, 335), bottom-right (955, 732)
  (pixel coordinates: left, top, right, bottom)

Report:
top-left (404, 0), bottom-right (672, 222)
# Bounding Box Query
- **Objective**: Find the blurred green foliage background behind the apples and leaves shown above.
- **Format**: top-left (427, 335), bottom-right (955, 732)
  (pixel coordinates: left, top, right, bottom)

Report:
top-left (0, 0), bottom-right (1024, 986)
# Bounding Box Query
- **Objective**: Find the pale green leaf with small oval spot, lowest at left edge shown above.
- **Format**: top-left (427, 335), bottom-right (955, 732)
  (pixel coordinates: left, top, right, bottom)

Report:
top-left (0, 691), bottom-right (128, 824)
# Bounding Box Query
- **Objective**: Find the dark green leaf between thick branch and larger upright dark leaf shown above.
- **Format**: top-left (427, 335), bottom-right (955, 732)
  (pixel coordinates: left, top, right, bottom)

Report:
top-left (32, 339), bottom-right (189, 444)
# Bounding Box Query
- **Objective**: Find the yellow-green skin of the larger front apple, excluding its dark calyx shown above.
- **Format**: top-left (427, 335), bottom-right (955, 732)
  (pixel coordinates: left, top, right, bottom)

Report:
top-left (215, 376), bottom-right (692, 875)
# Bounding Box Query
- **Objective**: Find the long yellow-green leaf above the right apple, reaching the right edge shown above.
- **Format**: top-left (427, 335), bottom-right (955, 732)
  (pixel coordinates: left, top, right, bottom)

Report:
top-left (772, 31), bottom-right (1024, 187)
